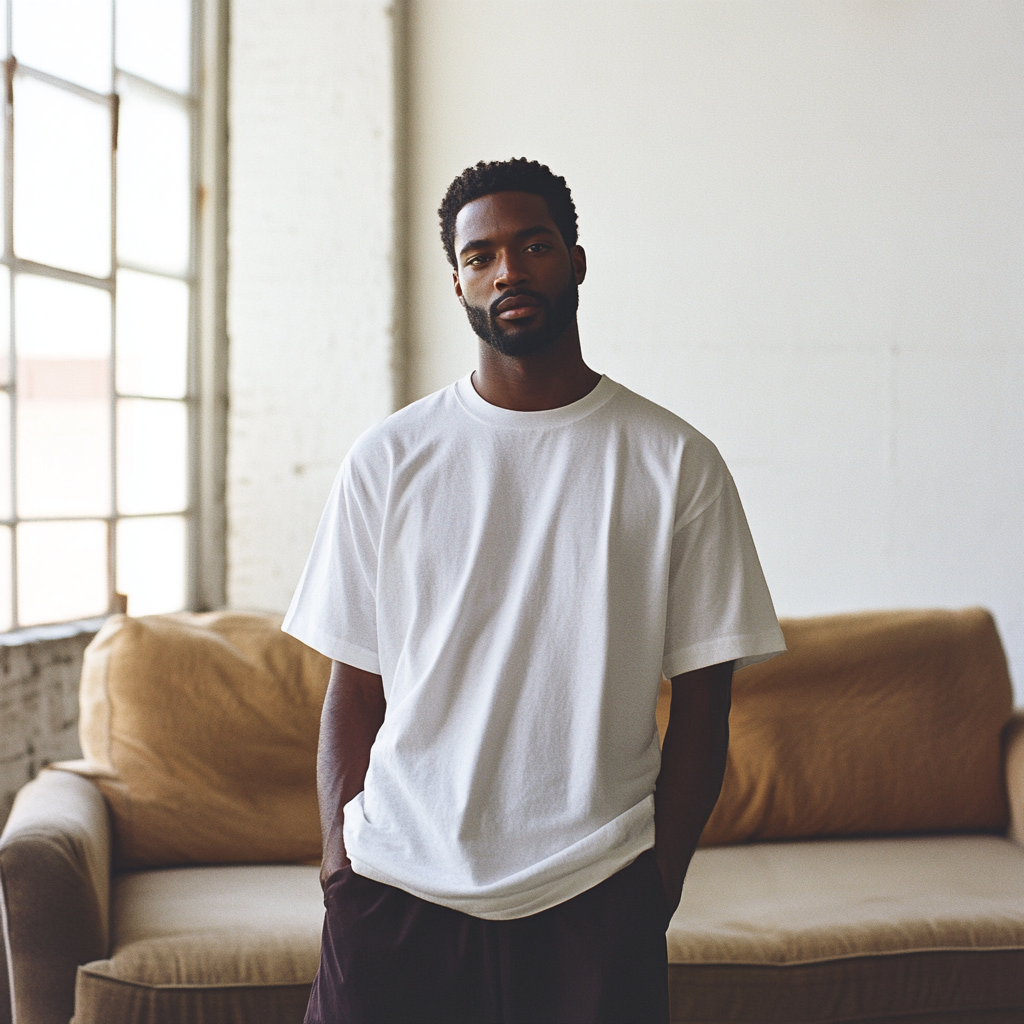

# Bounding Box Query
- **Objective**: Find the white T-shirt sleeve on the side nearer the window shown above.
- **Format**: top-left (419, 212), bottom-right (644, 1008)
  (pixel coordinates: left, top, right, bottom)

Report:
top-left (282, 456), bottom-right (381, 674)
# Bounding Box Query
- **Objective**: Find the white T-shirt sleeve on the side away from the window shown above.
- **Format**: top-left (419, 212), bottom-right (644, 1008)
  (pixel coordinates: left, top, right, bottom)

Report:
top-left (662, 470), bottom-right (785, 679)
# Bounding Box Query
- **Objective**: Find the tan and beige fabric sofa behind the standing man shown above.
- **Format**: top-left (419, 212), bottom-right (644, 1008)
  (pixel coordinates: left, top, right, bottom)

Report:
top-left (0, 610), bottom-right (1024, 1024)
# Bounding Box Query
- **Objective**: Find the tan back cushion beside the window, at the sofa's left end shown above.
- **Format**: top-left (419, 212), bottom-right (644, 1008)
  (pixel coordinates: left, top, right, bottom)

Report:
top-left (59, 612), bottom-right (330, 866)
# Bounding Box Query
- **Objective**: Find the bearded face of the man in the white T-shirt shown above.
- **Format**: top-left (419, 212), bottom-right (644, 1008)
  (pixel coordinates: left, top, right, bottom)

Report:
top-left (453, 191), bottom-right (587, 356)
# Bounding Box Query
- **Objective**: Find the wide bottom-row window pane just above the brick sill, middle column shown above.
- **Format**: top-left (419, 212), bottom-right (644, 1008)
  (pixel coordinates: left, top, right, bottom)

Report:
top-left (17, 521), bottom-right (108, 626)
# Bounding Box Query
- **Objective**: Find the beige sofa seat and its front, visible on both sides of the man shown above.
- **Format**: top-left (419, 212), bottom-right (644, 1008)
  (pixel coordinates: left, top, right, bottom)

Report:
top-left (68, 836), bottom-right (1024, 1024)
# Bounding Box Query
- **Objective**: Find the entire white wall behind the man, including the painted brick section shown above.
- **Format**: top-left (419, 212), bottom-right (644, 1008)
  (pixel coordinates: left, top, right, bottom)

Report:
top-left (228, 0), bottom-right (1024, 701)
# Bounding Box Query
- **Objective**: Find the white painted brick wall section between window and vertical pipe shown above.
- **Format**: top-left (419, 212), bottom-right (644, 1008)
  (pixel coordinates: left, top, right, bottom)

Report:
top-left (227, 0), bottom-right (401, 609)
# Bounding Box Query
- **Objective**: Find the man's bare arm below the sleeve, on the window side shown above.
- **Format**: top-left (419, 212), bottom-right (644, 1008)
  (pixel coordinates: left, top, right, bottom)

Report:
top-left (316, 662), bottom-right (386, 888)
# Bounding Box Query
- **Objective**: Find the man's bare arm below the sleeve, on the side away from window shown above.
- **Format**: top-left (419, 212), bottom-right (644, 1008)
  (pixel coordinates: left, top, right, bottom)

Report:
top-left (654, 662), bottom-right (732, 909)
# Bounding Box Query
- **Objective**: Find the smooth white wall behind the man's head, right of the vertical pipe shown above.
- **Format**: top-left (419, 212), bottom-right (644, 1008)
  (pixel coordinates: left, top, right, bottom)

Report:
top-left (407, 0), bottom-right (1024, 701)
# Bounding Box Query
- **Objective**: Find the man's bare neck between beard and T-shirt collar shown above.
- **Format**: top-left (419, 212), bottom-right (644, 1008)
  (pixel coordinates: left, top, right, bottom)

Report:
top-left (472, 325), bottom-right (601, 413)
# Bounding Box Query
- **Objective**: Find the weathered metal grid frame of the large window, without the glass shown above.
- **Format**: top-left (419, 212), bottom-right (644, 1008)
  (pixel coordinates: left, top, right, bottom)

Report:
top-left (0, 0), bottom-right (228, 630)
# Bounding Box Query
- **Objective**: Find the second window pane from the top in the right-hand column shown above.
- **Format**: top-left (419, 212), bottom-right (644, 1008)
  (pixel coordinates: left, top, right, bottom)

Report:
top-left (118, 82), bottom-right (190, 273)
